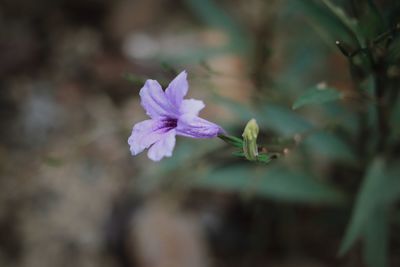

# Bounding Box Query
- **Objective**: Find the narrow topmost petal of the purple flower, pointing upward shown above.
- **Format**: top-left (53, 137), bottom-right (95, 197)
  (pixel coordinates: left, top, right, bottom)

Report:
top-left (165, 71), bottom-right (189, 108)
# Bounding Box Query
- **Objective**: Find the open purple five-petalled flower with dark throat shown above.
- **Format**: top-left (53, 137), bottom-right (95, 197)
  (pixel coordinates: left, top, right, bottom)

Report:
top-left (128, 71), bottom-right (223, 161)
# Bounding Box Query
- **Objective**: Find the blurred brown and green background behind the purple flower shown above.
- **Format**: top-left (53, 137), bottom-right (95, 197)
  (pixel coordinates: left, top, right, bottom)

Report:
top-left (0, 0), bottom-right (400, 267)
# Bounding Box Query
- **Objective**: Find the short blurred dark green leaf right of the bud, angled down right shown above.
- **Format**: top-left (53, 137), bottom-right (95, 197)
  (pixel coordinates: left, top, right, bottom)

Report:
top-left (304, 131), bottom-right (357, 163)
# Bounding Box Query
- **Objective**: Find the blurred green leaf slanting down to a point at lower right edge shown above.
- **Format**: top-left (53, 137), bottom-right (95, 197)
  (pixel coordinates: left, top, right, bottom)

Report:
top-left (339, 158), bottom-right (400, 255)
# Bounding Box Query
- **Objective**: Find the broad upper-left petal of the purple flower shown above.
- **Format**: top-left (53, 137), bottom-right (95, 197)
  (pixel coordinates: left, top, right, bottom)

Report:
top-left (139, 80), bottom-right (178, 119)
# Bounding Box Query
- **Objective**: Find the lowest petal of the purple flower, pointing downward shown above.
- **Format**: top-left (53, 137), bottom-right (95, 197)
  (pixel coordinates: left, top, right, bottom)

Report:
top-left (147, 129), bottom-right (176, 161)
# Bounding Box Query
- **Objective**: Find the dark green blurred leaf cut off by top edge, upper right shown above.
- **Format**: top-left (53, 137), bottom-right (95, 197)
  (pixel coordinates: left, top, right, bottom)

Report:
top-left (298, 0), bottom-right (360, 48)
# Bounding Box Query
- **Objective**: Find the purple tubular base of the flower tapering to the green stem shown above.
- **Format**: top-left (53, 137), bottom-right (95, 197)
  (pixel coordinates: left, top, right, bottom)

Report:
top-left (176, 114), bottom-right (223, 138)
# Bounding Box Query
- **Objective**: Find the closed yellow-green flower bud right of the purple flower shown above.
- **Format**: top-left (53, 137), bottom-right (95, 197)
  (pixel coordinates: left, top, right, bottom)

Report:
top-left (242, 119), bottom-right (259, 161)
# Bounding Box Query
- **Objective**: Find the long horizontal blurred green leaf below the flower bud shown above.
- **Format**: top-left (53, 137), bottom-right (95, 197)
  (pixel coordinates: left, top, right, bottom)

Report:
top-left (196, 165), bottom-right (344, 204)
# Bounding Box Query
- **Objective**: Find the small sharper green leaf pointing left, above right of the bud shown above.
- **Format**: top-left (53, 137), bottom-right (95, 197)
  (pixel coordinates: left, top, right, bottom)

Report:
top-left (292, 86), bottom-right (343, 109)
